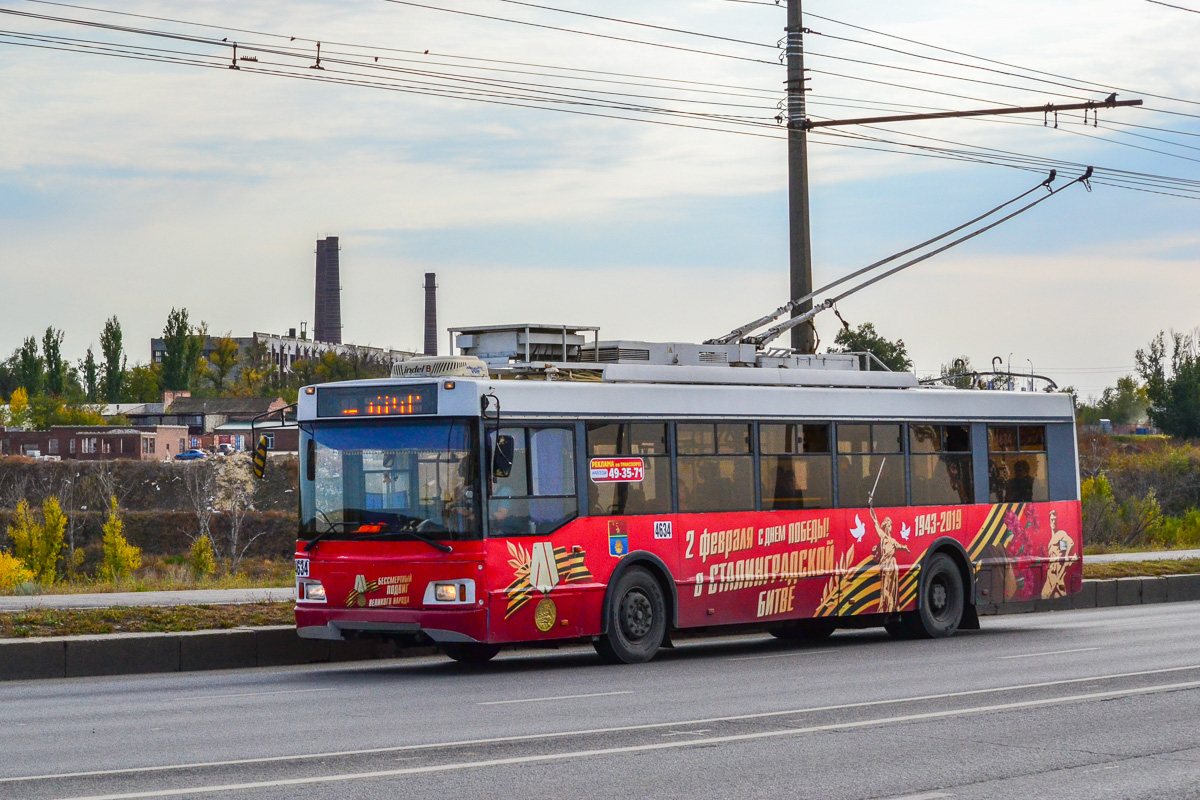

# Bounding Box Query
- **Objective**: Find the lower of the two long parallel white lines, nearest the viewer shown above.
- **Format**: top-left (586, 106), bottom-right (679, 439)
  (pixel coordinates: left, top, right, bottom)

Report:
top-left (39, 680), bottom-right (1200, 800)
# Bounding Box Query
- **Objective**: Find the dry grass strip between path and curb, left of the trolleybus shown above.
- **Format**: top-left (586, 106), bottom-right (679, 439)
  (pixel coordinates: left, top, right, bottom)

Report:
top-left (0, 602), bottom-right (295, 639)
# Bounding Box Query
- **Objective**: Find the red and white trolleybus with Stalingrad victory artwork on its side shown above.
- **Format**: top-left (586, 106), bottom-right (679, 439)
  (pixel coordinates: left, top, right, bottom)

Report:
top-left (295, 329), bottom-right (1082, 662)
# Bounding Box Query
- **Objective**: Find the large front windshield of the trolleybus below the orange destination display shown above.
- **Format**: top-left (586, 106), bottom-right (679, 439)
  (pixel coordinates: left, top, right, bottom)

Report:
top-left (300, 417), bottom-right (481, 541)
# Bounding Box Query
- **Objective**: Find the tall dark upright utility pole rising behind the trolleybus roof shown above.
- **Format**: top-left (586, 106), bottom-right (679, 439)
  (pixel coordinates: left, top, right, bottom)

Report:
top-left (786, 0), bottom-right (815, 353)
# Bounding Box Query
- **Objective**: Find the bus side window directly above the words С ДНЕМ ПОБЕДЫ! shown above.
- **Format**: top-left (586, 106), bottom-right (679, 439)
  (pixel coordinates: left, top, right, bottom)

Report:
top-left (758, 422), bottom-right (833, 511)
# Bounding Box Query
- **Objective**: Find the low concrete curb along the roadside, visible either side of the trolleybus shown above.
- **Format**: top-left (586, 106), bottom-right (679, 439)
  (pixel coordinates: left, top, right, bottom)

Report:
top-left (7, 575), bottom-right (1200, 680)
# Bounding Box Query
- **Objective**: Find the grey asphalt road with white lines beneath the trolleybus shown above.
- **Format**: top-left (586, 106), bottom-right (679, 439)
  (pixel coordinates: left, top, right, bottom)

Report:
top-left (0, 603), bottom-right (1200, 800)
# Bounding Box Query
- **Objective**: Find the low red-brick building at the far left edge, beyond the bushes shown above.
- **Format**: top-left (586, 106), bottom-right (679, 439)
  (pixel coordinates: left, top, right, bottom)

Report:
top-left (0, 425), bottom-right (187, 461)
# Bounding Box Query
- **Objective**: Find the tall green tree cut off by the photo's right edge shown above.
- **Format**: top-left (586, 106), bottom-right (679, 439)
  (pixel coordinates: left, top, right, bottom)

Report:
top-left (1136, 331), bottom-right (1200, 439)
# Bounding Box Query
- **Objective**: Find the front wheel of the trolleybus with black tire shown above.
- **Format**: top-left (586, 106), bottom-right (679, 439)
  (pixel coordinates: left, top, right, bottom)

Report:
top-left (595, 566), bottom-right (667, 664)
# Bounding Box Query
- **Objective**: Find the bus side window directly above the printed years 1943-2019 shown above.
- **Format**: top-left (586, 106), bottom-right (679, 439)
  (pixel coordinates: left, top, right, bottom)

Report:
top-left (908, 425), bottom-right (974, 506)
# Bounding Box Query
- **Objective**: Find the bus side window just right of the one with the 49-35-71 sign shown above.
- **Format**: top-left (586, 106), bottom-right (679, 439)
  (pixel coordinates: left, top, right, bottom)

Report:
top-left (676, 422), bottom-right (754, 513)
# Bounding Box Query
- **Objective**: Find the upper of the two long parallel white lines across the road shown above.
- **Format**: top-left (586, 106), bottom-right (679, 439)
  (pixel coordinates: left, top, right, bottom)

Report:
top-left (14, 664), bottom-right (1200, 784)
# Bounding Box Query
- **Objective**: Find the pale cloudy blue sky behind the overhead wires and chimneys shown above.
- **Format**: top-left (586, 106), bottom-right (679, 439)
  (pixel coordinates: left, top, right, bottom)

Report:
top-left (0, 0), bottom-right (1200, 397)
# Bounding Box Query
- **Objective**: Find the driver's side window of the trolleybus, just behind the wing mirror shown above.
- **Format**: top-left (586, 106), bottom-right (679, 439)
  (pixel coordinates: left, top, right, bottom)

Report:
top-left (487, 427), bottom-right (578, 536)
